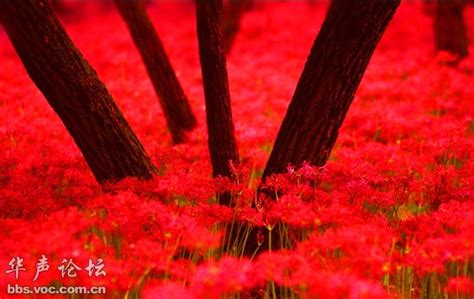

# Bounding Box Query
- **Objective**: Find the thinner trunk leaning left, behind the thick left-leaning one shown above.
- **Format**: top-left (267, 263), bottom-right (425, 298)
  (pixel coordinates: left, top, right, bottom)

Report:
top-left (115, 0), bottom-right (197, 144)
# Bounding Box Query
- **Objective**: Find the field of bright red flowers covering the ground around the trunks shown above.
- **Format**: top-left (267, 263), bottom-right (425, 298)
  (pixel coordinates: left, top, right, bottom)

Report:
top-left (0, 1), bottom-right (474, 298)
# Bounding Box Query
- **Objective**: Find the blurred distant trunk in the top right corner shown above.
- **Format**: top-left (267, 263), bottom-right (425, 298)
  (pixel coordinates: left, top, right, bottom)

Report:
top-left (433, 0), bottom-right (468, 59)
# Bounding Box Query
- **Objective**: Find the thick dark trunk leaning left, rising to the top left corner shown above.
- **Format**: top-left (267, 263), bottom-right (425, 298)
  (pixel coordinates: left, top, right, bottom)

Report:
top-left (0, 0), bottom-right (155, 183)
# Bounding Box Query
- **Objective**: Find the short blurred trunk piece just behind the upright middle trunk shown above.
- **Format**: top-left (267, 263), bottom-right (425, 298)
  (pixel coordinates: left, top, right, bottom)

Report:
top-left (222, 0), bottom-right (253, 55)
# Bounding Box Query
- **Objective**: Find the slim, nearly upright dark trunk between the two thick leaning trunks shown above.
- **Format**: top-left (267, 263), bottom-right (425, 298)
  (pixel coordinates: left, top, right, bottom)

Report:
top-left (196, 0), bottom-right (239, 204)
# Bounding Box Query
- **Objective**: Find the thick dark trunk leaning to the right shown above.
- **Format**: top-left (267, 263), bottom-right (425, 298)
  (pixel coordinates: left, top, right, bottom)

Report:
top-left (263, 0), bottom-right (400, 183)
